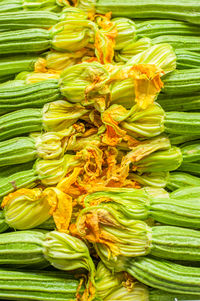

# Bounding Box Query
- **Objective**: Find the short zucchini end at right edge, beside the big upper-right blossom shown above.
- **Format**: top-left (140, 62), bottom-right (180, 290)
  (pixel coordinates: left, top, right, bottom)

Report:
top-left (176, 49), bottom-right (200, 69)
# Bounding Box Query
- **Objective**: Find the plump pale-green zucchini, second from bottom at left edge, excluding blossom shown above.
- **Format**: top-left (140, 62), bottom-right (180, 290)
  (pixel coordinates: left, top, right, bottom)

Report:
top-left (0, 230), bottom-right (49, 269)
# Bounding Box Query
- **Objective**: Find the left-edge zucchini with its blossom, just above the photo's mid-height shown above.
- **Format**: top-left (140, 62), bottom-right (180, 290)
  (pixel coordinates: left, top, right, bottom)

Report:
top-left (0, 100), bottom-right (88, 141)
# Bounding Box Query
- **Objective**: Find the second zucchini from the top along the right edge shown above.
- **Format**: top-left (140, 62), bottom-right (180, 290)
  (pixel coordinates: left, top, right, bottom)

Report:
top-left (136, 19), bottom-right (199, 38)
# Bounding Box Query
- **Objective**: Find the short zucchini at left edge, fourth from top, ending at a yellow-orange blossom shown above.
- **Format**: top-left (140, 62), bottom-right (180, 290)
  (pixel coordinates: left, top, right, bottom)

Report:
top-left (0, 54), bottom-right (38, 80)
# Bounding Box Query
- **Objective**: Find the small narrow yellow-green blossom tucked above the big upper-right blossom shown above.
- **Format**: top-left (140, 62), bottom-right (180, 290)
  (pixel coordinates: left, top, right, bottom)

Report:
top-left (115, 38), bottom-right (152, 63)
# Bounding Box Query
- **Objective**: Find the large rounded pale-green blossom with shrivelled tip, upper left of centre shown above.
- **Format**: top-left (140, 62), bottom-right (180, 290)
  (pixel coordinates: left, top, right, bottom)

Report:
top-left (60, 62), bottom-right (109, 111)
